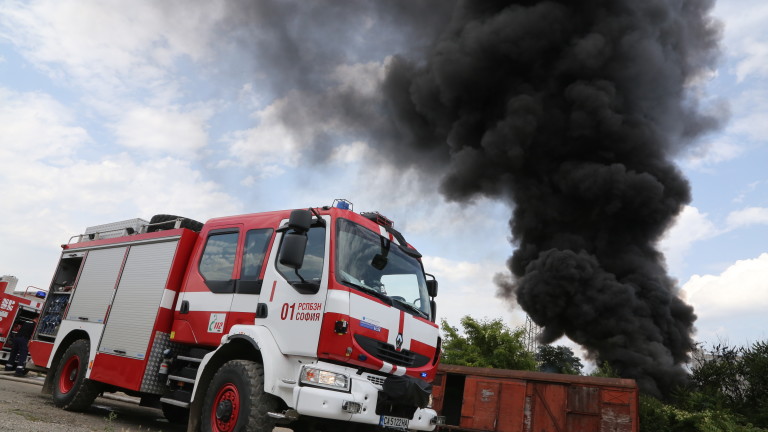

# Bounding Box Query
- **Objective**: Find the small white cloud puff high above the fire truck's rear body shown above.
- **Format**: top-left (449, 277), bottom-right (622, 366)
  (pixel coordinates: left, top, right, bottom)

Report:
top-left (115, 106), bottom-right (213, 157)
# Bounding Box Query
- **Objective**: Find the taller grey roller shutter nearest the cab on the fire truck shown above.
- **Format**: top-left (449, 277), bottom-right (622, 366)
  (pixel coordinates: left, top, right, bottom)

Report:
top-left (99, 240), bottom-right (178, 359)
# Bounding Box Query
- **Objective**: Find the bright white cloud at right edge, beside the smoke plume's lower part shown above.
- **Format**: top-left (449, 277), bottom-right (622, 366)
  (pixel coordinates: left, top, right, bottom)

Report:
top-left (683, 253), bottom-right (768, 320)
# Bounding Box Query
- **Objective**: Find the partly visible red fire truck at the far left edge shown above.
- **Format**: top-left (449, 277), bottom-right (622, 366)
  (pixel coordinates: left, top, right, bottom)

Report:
top-left (0, 275), bottom-right (45, 364)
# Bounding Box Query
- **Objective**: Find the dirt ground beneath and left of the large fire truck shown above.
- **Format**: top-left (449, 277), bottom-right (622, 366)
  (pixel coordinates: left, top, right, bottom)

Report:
top-left (0, 373), bottom-right (288, 432)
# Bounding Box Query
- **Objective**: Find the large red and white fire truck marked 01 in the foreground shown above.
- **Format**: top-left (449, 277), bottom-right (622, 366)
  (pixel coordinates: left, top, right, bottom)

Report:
top-left (30, 200), bottom-right (440, 432)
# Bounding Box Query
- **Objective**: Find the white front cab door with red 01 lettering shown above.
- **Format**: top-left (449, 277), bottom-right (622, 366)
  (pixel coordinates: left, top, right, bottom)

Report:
top-left (256, 216), bottom-right (330, 356)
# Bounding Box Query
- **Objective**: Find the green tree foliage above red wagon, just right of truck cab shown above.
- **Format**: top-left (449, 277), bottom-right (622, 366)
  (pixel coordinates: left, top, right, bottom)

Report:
top-left (441, 316), bottom-right (536, 370)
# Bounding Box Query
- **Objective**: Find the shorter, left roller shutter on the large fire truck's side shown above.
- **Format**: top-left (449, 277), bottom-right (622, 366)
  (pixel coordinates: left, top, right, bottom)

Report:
top-left (66, 247), bottom-right (127, 323)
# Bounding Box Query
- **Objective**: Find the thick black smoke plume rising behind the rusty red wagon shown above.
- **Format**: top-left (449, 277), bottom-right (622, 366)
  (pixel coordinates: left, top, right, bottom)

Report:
top-left (384, 0), bottom-right (720, 395)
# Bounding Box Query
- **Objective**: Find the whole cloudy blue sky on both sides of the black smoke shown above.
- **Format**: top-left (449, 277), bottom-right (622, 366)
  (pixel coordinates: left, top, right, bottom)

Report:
top-left (0, 0), bottom-right (768, 354)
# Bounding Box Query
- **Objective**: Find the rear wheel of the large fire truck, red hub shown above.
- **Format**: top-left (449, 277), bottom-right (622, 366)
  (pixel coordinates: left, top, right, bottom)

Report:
top-left (53, 339), bottom-right (101, 411)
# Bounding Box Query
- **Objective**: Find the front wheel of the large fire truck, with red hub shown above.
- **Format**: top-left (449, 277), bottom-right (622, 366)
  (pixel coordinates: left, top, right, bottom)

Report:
top-left (200, 360), bottom-right (278, 432)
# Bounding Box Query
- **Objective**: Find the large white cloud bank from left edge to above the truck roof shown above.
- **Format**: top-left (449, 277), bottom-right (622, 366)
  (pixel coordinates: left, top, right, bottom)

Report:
top-left (0, 88), bottom-right (242, 284)
